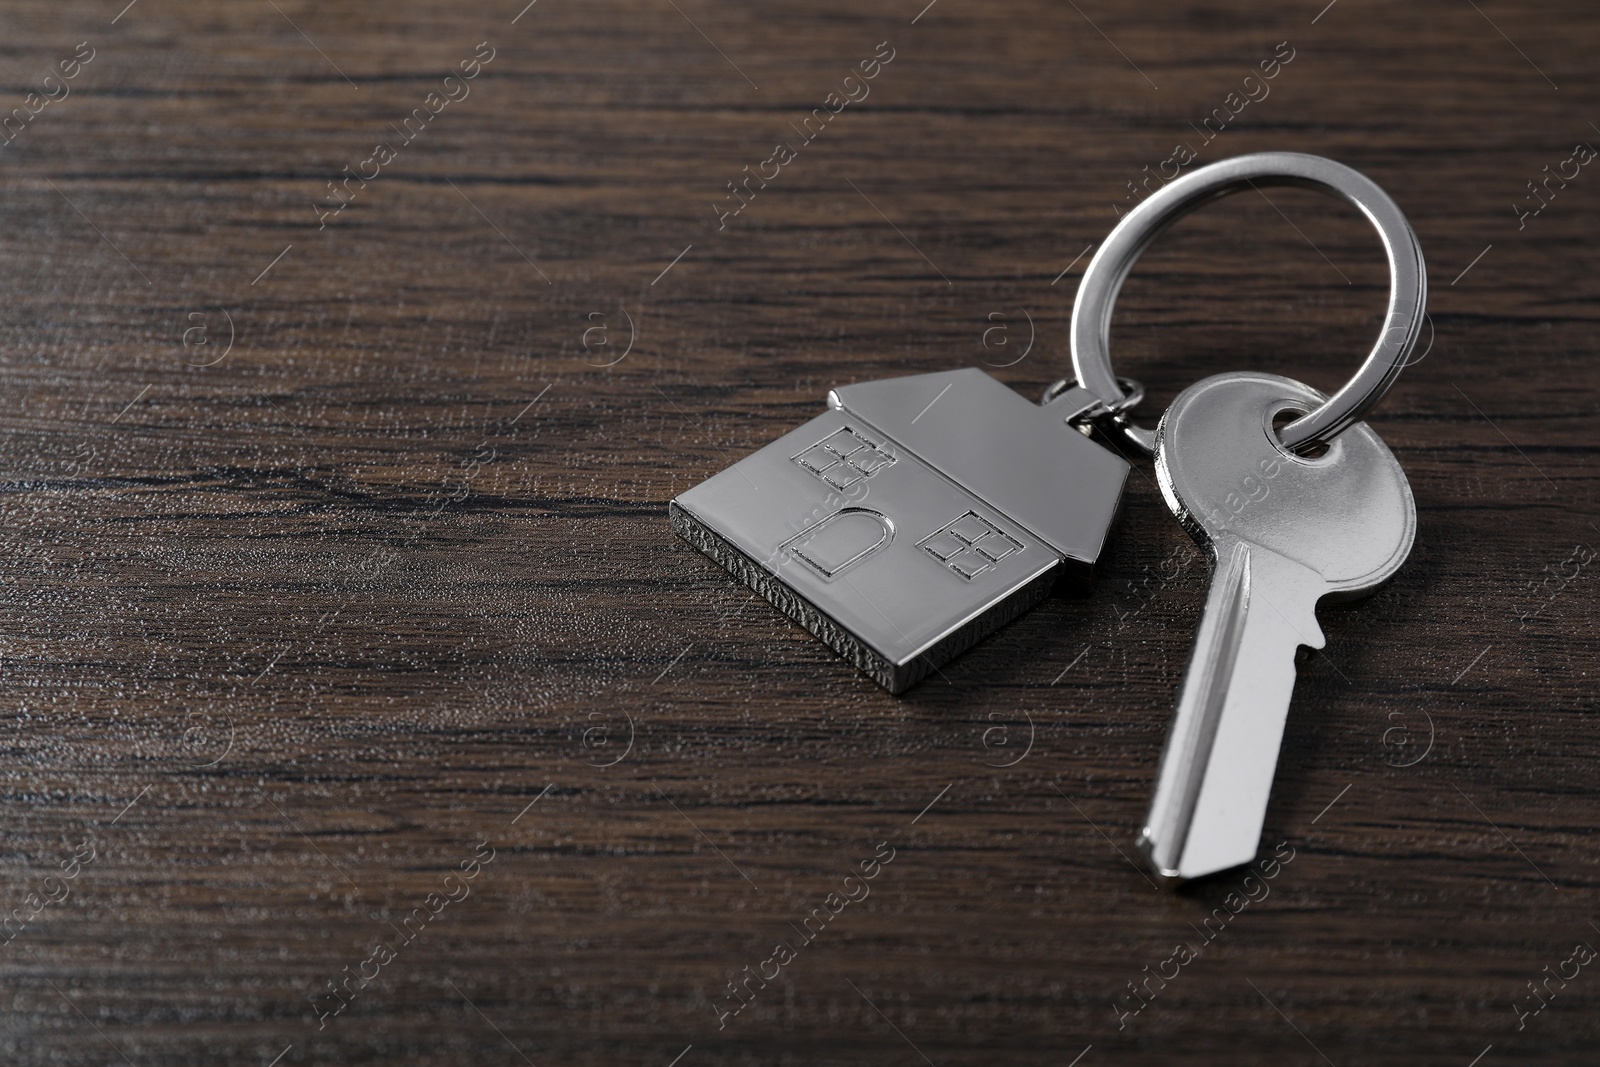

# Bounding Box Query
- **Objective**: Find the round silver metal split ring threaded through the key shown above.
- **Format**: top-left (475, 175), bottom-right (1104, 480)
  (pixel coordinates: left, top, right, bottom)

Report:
top-left (1072, 152), bottom-right (1427, 453)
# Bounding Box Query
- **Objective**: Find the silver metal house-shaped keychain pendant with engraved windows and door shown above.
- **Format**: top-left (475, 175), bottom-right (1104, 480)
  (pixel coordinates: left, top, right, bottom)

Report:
top-left (669, 368), bottom-right (1128, 693)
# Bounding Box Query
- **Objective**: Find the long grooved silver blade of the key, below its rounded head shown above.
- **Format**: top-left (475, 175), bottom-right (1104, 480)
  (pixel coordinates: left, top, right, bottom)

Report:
top-left (1139, 541), bottom-right (1326, 878)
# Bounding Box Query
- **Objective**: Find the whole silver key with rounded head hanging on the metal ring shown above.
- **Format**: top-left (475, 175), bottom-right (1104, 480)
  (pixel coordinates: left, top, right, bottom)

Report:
top-left (1139, 373), bottom-right (1416, 878)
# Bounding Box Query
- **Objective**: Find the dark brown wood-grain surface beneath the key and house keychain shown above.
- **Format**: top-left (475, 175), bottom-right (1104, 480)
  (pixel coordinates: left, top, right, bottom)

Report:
top-left (0, 0), bottom-right (1600, 1067)
